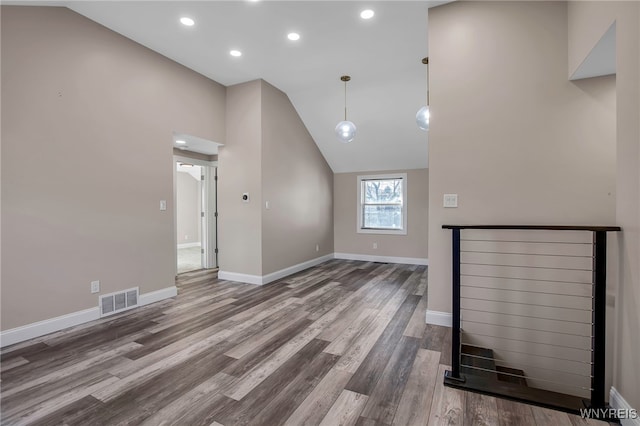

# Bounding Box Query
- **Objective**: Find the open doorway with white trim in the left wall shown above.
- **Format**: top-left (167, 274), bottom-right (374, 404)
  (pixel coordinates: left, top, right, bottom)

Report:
top-left (174, 156), bottom-right (218, 274)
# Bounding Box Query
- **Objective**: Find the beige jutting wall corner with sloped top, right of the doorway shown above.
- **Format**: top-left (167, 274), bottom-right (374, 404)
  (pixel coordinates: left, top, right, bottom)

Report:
top-left (218, 80), bottom-right (333, 276)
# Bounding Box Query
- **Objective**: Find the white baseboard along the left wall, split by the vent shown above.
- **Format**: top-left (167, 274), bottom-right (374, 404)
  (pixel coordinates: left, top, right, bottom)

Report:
top-left (0, 286), bottom-right (178, 347)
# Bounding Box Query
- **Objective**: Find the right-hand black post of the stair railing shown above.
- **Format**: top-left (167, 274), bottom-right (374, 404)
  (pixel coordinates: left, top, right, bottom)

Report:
top-left (591, 231), bottom-right (607, 408)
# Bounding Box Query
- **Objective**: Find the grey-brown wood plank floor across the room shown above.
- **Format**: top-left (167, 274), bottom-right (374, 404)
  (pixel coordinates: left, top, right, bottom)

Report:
top-left (0, 260), bottom-right (608, 426)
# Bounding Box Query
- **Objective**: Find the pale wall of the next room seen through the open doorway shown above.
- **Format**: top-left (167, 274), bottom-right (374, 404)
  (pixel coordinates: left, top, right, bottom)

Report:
top-left (176, 172), bottom-right (202, 245)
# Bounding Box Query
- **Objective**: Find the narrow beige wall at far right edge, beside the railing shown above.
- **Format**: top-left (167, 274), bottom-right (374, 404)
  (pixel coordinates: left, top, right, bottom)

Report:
top-left (613, 2), bottom-right (640, 408)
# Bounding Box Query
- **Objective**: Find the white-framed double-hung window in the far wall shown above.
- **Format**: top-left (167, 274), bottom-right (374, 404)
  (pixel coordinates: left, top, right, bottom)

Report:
top-left (358, 173), bottom-right (407, 235)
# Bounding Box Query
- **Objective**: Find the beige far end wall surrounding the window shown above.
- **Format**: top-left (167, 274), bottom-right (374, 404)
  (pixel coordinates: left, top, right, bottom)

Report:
top-left (333, 169), bottom-right (429, 260)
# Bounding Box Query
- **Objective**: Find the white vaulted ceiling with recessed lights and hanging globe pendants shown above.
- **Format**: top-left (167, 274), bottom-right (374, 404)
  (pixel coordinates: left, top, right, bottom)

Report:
top-left (21, 0), bottom-right (446, 173)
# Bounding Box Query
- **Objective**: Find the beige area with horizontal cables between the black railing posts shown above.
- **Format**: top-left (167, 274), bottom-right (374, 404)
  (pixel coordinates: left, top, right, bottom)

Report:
top-left (460, 230), bottom-right (593, 398)
